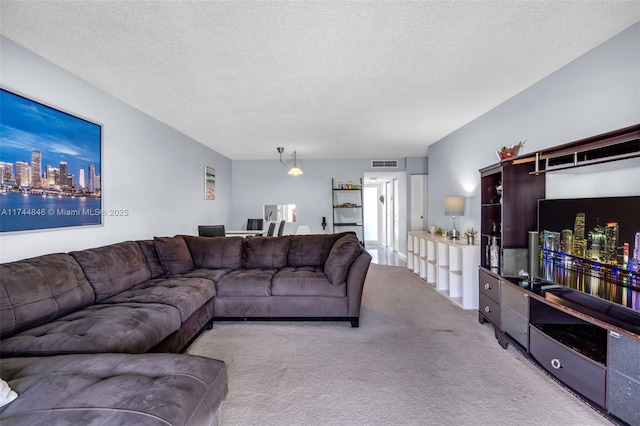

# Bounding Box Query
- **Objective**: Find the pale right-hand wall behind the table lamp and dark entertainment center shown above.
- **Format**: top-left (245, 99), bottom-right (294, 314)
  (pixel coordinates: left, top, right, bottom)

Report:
top-left (428, 24), bottom-right (640, 238)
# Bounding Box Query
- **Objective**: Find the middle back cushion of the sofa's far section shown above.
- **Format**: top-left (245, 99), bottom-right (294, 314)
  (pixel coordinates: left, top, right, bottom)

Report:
top-left (243, 237), bottom-right (291, 269)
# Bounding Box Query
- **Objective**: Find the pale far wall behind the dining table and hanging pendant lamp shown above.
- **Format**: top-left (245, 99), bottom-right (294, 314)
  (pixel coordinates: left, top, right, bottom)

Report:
top-left (229, 159), bottom-right (416, 253)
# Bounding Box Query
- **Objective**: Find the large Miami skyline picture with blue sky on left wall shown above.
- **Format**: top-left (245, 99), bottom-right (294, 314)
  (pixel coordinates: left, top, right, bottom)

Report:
top-left (0, 88), bottom-right (103, 232)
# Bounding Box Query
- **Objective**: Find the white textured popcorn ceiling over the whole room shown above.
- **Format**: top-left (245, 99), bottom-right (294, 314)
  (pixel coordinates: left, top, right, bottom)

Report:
top-left (0, 0), bottom-right (640, 159)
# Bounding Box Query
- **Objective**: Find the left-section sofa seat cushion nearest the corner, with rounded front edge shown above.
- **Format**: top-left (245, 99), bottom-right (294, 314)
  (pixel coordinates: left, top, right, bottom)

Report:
top-left (102, 277), bottom-right (216, 322)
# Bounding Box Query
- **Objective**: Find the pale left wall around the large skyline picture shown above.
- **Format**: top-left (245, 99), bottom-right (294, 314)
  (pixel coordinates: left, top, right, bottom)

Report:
top-left (0, 37), bottom-right (232, 262)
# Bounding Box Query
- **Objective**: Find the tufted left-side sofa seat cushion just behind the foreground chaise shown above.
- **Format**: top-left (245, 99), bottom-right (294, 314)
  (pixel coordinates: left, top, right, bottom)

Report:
top-left (0, 303), bottom-right (181, 358)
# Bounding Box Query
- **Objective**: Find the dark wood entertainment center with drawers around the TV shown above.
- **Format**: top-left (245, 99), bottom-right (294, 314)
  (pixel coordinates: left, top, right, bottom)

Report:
top-left (478, 124), bottom-right (640, 425)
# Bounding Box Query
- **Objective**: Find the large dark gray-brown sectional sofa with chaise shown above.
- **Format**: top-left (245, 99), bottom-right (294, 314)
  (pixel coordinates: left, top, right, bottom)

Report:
top-left (0, 233), bottom-right (371, 425)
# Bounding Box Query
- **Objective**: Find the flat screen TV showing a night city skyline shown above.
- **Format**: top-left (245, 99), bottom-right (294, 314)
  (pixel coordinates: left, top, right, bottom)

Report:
top-left (538, 196), bottom-right (640, 310)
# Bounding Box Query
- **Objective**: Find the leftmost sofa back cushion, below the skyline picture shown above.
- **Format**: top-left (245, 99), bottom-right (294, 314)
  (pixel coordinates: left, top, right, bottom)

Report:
top-left (0, 253), bottom-right (95, 337)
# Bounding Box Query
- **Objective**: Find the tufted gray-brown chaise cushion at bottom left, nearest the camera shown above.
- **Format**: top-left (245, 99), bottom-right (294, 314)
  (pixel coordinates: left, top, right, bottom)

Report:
top-left (0, 354), bottom-right (228, 426)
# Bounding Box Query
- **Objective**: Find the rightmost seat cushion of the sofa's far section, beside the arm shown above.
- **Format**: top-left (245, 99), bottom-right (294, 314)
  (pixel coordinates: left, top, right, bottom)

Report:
top-left (271, 266), bottom-right (347, 297)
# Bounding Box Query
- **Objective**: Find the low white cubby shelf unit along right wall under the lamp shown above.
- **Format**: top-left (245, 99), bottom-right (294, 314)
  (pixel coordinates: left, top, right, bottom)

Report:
top-left (407, 231), bottom-right (480, 309)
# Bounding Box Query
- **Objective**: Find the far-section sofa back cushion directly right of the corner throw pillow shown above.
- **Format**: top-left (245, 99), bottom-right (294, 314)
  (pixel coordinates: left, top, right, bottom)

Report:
top-left (183, 235), bottom-right (244, 269)
